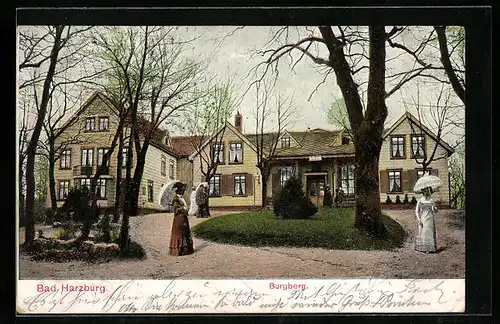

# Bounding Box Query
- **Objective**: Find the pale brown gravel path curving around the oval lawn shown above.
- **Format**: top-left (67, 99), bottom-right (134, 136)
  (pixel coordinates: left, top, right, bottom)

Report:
top-left (19, 210), bottom-right (465, 279)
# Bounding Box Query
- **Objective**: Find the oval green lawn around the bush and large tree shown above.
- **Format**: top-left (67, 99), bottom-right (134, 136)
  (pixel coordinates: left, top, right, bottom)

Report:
top-left (192, 208), bottom-right (407, 250)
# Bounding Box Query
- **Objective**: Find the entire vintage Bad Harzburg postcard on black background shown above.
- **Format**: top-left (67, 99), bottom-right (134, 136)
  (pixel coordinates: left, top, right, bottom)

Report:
top-left (16, 19), bottom-right (466, 315)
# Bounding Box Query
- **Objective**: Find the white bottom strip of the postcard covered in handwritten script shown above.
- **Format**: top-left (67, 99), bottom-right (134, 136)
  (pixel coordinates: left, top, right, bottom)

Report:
top-left (17, 279), bottom-right (465, 314)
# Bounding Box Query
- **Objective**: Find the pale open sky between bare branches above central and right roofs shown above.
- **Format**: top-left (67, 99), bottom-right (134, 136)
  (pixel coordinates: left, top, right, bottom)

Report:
top-left (172, 26), bottom-right (460, 146)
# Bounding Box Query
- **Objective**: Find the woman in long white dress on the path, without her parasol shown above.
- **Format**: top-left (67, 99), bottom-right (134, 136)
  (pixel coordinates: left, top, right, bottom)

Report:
top-left (415, 187), bottom-right (437, 253)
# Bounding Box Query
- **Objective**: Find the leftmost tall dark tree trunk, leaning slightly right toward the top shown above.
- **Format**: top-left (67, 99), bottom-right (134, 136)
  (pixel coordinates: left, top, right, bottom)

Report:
top-left (24, 26), bottom-right (64, 251)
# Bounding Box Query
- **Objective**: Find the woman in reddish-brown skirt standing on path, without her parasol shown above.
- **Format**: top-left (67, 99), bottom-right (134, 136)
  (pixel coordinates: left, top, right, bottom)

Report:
top-left (169, 182), bottom-right (194, 256)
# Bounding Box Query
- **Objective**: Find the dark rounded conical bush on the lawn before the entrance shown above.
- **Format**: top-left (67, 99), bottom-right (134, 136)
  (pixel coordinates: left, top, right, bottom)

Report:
top-left (273, 177), bottom-right (318, 219)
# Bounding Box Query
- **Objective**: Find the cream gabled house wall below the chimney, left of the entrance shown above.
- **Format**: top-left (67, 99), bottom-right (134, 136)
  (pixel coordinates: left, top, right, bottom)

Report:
top-left (193, 127), bottom-right (262, 207)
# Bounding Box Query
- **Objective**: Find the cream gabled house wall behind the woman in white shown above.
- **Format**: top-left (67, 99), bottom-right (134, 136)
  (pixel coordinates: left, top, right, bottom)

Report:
top-left (379, 119), bottom-right (449, 204)
